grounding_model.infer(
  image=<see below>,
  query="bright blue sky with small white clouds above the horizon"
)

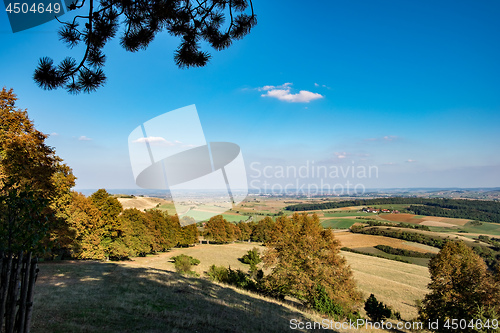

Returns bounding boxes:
[0,0,500,190]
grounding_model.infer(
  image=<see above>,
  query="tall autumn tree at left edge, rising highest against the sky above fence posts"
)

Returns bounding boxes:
[0,88,75,251]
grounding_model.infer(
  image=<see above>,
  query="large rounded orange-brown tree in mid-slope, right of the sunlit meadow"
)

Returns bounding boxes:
[263,214,361,317]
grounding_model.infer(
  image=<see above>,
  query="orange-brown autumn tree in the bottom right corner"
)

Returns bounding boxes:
[419,241,500,332]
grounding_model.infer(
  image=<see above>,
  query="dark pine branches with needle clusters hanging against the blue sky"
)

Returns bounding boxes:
[33,0,257,94]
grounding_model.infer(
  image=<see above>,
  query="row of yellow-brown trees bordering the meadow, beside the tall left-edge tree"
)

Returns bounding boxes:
[49,189,198,260]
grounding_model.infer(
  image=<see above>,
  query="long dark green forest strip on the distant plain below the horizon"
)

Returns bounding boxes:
[285,197,500,223]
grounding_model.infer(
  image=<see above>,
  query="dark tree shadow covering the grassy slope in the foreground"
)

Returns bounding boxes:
[32,261,336,333]
